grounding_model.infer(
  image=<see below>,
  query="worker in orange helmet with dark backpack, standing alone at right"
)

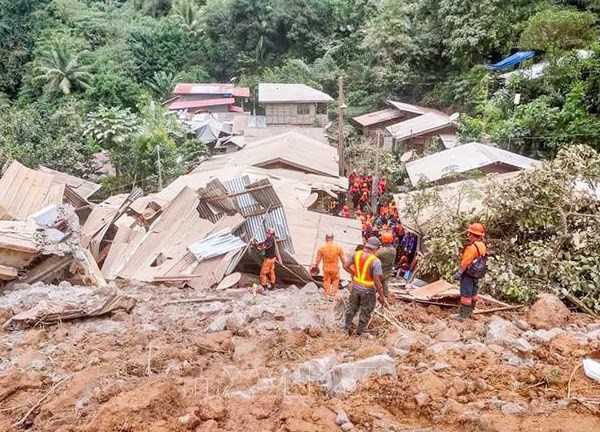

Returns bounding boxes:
[454,223,487,321]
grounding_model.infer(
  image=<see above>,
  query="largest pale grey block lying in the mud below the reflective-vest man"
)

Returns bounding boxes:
[327,355,397,395]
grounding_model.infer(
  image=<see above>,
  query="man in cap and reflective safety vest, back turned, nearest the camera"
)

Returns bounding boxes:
[344,237,387,336]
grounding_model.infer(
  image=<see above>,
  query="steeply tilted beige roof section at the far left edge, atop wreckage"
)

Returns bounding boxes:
[0,161,64,220]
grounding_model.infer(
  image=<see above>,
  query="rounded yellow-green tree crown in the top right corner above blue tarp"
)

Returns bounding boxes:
[520,9,597,52]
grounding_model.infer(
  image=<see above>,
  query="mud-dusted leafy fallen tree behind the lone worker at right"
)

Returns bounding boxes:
[403,145,600,313]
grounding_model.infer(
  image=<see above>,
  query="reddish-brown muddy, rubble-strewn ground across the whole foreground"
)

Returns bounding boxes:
[0,283,600,432]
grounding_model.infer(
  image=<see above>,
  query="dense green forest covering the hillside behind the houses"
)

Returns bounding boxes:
[0,0,600,192]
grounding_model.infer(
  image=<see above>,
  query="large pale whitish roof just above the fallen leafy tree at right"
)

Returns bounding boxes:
[406,142,537,185]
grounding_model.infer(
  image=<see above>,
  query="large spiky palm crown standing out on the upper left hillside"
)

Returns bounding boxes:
[35,44,91,95]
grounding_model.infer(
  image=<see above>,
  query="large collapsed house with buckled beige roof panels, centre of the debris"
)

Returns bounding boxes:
[81,132,361,289]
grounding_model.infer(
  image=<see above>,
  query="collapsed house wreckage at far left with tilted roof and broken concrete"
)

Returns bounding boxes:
[0,161,105,286]
